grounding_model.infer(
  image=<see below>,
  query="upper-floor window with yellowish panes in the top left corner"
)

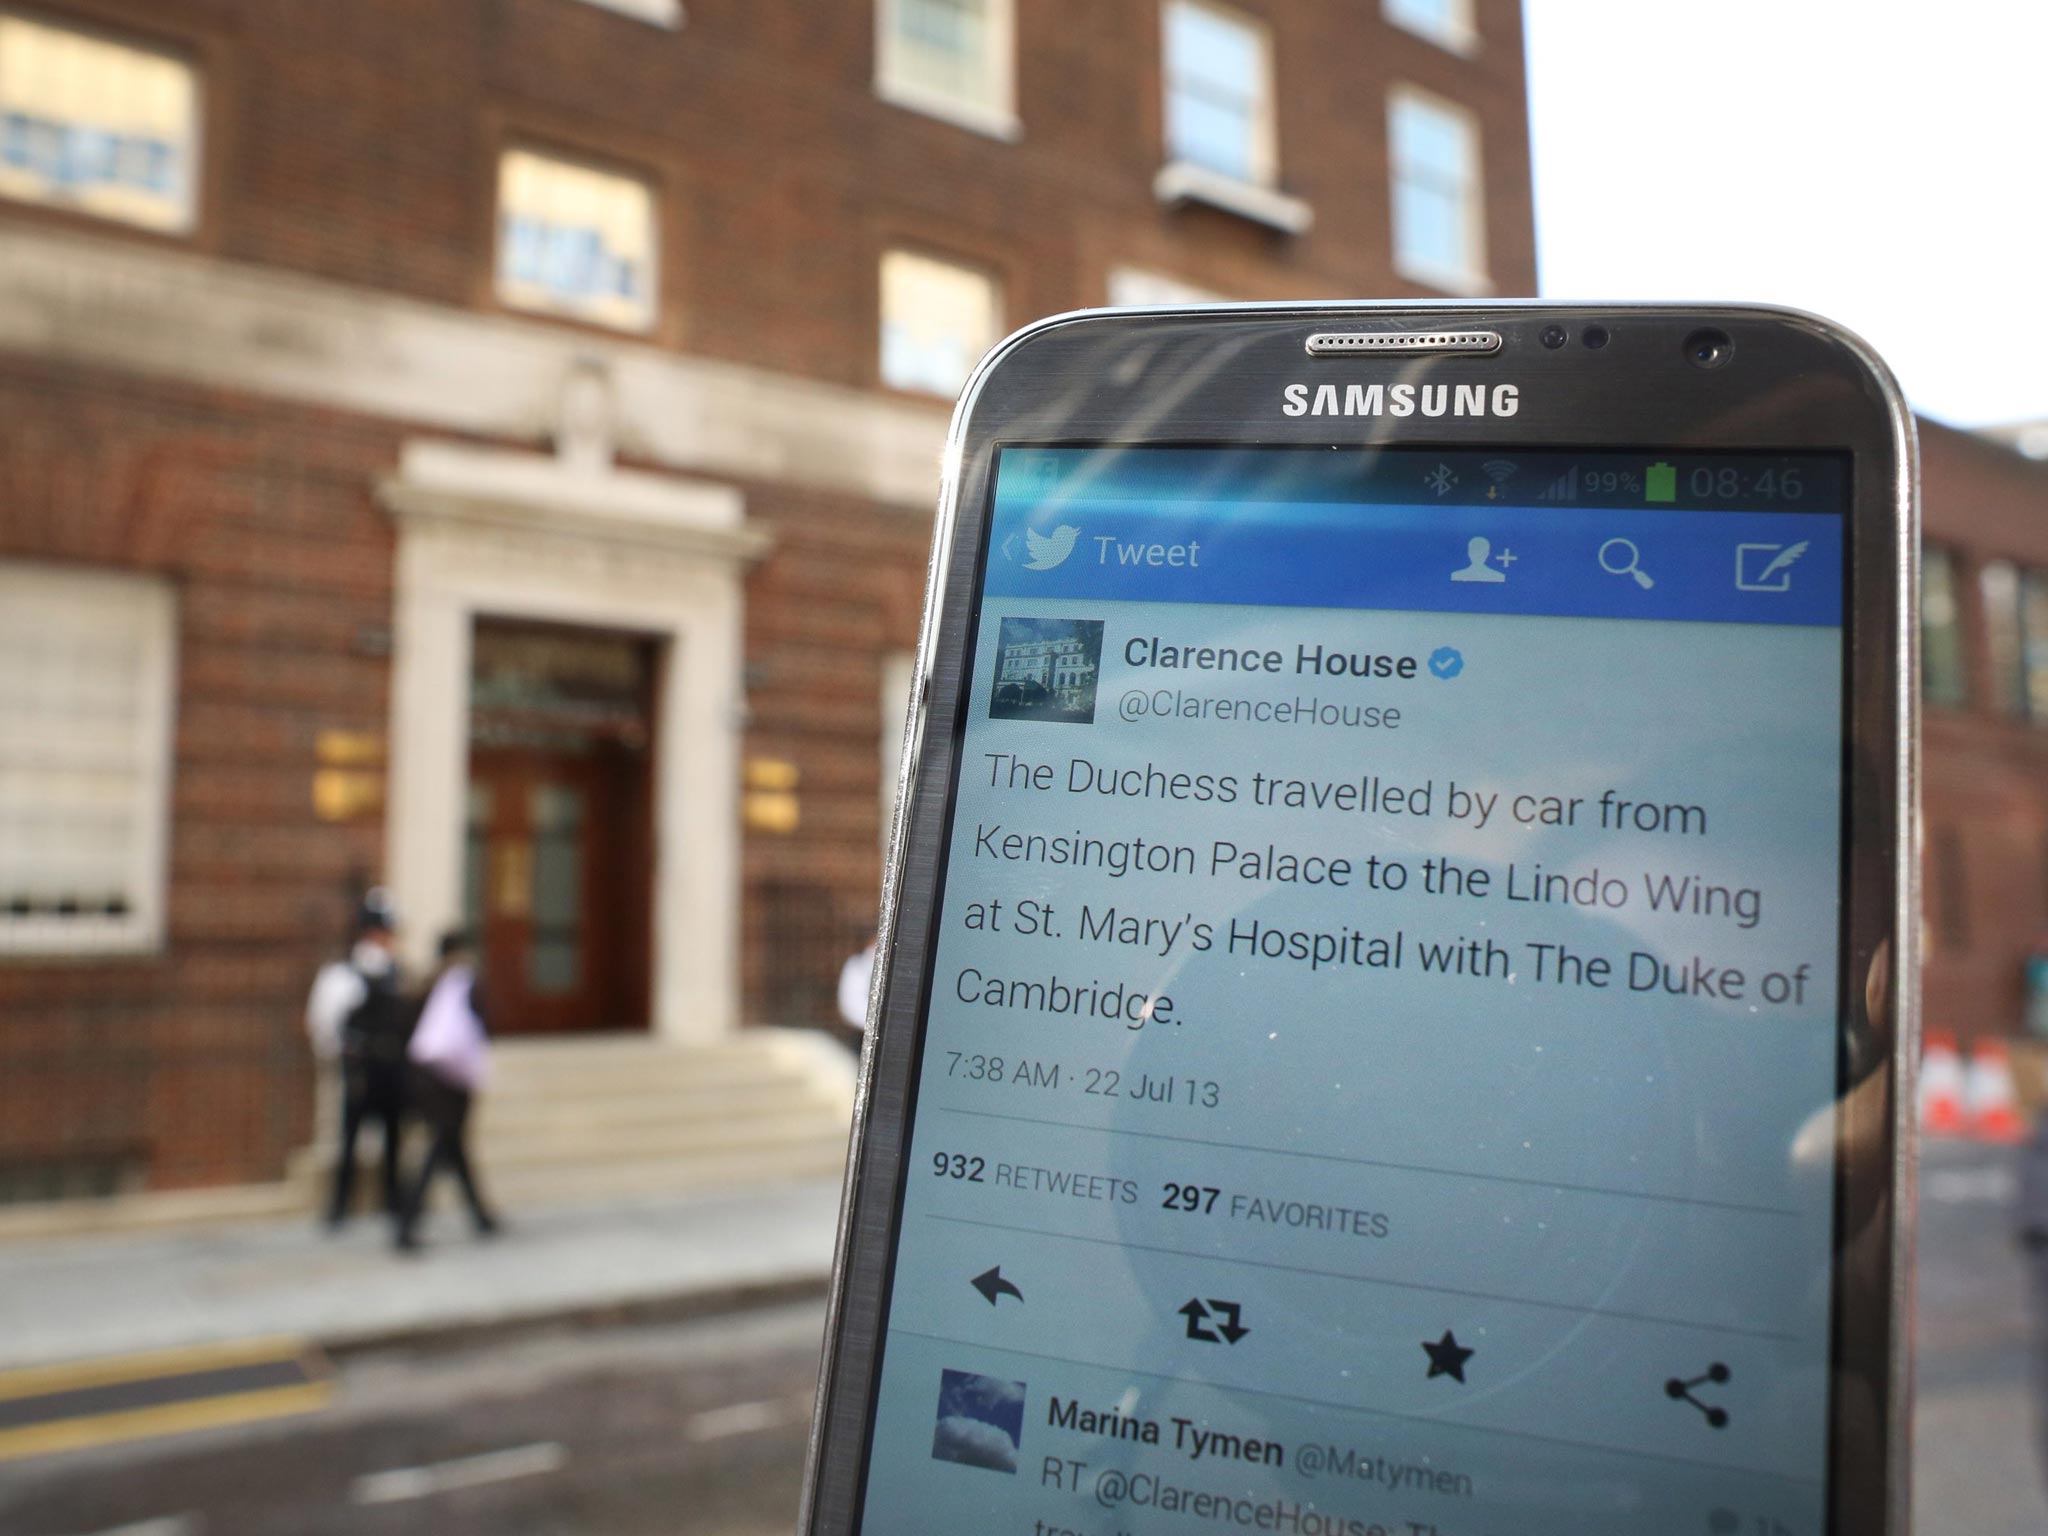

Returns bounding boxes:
[0,14,199,233]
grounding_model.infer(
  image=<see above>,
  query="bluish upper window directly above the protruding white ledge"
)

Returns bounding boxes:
[1165,0,1278,186]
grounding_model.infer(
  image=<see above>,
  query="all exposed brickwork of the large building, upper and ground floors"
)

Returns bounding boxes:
[0,0,1534,1186]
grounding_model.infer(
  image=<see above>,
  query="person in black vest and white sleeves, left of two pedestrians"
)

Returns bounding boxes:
[305,889,418,1229]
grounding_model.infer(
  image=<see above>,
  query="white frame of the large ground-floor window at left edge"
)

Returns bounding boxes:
[0,559,178,961]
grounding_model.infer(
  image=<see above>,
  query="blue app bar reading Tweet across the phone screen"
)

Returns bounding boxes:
[985,449,1843,627]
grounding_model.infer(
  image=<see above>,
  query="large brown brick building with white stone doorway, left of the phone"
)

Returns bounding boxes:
[0,0,1534,1200]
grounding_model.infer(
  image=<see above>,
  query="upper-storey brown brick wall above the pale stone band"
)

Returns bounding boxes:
[47,0,1536,372]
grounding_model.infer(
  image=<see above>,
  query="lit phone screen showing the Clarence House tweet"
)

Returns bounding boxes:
[862,446,1849,1536]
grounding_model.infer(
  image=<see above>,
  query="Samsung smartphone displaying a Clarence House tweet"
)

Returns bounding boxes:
[803,305,1915,1536]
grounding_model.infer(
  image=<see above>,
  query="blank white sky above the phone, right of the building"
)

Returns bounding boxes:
[1524,0,2048,426]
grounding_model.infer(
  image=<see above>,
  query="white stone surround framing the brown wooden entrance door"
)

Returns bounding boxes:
[381,421,770,1044]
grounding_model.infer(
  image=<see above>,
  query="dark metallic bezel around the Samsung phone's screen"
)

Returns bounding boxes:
[799,301,1919,1536]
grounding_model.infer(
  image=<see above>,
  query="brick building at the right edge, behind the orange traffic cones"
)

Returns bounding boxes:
[1921,422,2048,1040]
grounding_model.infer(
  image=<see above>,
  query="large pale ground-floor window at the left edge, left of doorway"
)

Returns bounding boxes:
[0,561,176,954]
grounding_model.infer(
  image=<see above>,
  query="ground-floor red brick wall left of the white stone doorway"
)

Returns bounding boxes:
[0,358,395,1186]
